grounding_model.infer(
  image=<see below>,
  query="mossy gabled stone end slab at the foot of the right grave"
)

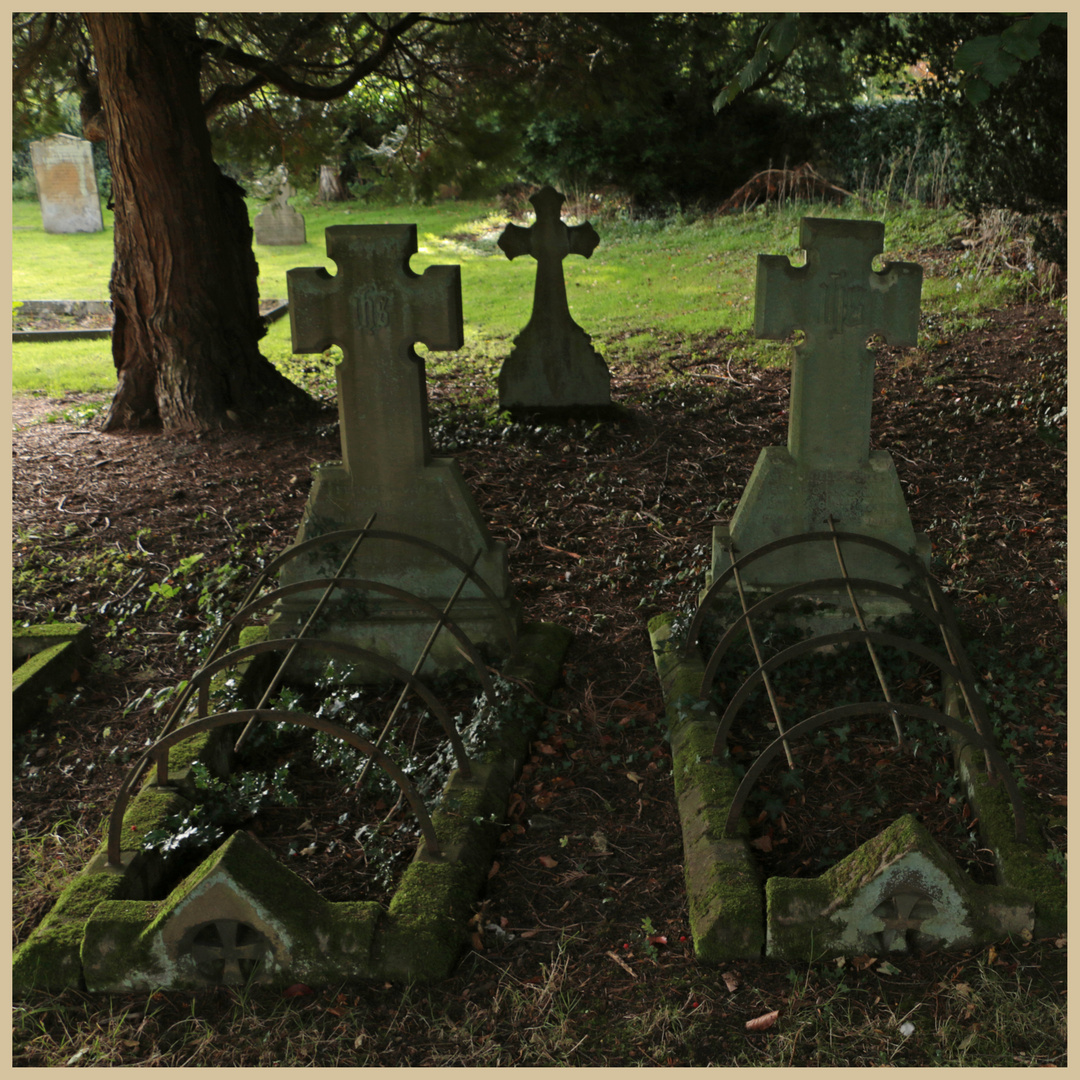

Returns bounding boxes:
[765,814,1035,961]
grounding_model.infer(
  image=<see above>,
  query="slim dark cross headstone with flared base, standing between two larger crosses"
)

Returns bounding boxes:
[499,186,611,411]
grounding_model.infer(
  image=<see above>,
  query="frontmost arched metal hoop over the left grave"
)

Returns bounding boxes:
[107,708,442,866]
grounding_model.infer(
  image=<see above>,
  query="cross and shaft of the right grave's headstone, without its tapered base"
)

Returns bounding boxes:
[754,217,922,471]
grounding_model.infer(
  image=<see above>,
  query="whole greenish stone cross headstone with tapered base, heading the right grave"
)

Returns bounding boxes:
[713,218,922,590]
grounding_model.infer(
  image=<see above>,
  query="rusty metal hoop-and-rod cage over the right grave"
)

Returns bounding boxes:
[684,516,1027,840]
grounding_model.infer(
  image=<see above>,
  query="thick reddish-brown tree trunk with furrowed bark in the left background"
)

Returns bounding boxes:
[85,13,313,431]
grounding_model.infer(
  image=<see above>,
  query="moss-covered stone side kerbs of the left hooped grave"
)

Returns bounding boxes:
[13,623,573,994]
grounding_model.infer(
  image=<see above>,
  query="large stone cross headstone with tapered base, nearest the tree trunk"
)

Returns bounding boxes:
[282,225,516,669]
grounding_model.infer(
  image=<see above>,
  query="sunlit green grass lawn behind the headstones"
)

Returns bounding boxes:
[12,197,1036,396]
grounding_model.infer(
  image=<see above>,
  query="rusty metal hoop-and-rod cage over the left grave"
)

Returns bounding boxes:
[107,514,516,866]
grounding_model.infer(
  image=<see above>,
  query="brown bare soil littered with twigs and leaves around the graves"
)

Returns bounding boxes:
[13,291,1066,1066]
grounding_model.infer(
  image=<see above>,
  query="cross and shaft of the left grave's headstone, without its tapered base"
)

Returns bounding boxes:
[286,225,464,490]
